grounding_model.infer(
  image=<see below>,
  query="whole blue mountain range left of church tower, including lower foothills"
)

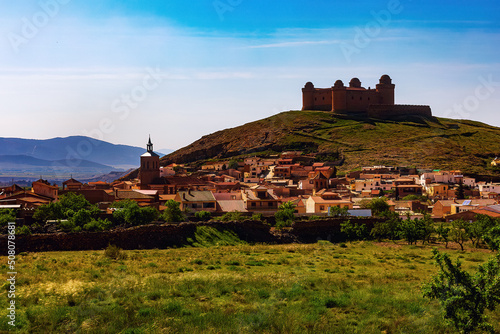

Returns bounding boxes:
[0,136,171,180]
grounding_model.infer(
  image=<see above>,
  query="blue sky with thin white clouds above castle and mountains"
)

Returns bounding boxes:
[0,0,500,149]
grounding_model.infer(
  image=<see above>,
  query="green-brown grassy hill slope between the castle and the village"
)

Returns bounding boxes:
[161,111,500,177]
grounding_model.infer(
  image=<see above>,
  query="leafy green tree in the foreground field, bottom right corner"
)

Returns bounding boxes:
[424,249,500,333]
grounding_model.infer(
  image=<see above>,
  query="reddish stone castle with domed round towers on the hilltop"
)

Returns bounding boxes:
[302,74,432,119]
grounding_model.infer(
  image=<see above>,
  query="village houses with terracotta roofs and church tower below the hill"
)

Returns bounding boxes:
[0,141,500,219]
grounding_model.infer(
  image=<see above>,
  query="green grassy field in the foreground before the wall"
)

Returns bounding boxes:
[0,228,500,333]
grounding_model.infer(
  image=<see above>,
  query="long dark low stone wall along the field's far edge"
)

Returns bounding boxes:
[0,218,386,253]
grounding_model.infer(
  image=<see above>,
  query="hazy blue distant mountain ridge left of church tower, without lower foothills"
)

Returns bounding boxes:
[0,136,145,168]
